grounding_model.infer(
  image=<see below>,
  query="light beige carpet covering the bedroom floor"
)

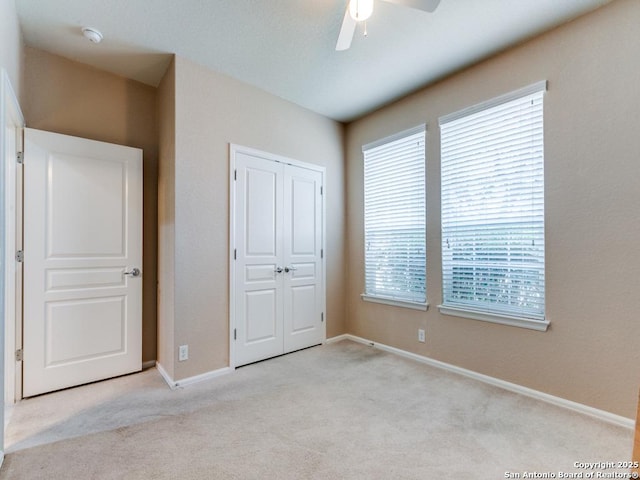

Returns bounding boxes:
[0,341,632,480]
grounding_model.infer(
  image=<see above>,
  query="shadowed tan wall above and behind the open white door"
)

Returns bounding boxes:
[22,47,158,361]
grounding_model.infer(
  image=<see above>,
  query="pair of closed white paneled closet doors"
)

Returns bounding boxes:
[232,151,325,366]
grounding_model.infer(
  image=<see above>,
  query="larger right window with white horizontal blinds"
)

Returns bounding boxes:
[440,82,548,330]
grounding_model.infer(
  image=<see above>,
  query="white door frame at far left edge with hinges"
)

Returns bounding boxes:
[0,68,25,464]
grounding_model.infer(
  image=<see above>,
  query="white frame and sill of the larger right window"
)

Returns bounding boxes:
[438,81,550,331]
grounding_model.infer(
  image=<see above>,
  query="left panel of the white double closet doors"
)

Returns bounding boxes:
[232,153,284,365]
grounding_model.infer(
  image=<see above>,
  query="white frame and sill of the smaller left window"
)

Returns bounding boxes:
[360,124,428,311]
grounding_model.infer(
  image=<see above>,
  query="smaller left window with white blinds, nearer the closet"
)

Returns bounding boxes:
[362,125,426,309]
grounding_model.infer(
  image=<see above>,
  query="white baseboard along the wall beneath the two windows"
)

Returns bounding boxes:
[340,334,635,430]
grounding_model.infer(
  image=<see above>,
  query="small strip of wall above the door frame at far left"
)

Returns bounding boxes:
[0,0,23,99]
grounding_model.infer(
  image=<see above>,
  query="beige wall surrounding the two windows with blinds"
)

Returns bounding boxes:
[346,0,640,418]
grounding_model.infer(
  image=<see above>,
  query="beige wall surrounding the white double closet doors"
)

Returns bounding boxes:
[160,57,345,380]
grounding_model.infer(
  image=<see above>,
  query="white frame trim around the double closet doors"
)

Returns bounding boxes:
[229,143,327,369]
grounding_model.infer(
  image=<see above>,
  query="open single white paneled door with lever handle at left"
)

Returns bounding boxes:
[23,129,142,397]
